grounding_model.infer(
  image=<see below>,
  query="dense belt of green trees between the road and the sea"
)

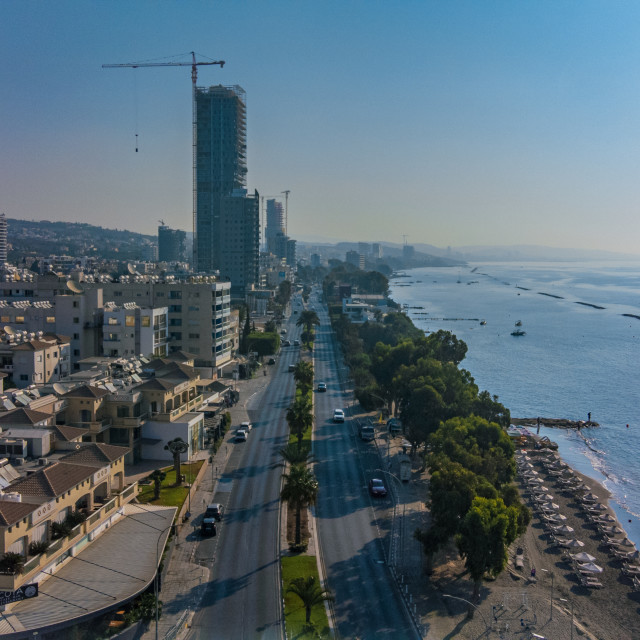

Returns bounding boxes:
[324,279,531,613]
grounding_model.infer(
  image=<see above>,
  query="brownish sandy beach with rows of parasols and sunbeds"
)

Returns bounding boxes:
[424,452,640,640]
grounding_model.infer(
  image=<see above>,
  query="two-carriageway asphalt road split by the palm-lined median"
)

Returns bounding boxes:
[188,297,418,640]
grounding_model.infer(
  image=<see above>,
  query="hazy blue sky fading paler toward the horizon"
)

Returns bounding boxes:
[0,0,640,253]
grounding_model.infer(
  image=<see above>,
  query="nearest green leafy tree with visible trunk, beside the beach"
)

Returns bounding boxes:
[456,498,517,618]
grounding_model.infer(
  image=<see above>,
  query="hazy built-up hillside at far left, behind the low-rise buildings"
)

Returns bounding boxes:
[7,218,157,262]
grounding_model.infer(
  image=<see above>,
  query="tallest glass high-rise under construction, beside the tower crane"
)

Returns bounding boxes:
[194,85,260,295]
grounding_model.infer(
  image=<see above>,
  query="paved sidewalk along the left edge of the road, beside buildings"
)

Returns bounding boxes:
[138,369,271,640]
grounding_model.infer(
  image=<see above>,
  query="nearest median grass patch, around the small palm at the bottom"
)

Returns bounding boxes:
[282,556,330,640]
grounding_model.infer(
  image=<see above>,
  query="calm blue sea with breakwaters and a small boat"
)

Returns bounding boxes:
[390,261,640,545]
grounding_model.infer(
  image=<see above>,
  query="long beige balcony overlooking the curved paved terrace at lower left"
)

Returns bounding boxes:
[0,482,138,591]
